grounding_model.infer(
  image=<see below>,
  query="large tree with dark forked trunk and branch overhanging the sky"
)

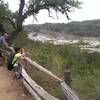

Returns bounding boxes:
[0,0,81,36]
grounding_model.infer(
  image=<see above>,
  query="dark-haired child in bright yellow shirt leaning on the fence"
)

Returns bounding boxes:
[12,47,25,79]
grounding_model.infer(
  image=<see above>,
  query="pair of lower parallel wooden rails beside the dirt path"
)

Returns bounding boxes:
[22,69,59,100]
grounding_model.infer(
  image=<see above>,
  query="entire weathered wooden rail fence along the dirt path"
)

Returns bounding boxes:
[4,50,80,100]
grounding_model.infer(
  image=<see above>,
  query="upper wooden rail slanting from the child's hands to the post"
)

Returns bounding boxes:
[25,57,63,82]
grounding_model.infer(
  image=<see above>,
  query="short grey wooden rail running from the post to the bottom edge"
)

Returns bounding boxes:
[60,82,80,100]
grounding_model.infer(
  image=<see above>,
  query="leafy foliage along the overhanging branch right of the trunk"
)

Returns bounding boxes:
[28,0,81,19]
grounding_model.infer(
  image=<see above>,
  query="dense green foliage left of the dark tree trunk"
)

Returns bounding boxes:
[0,0,15,33]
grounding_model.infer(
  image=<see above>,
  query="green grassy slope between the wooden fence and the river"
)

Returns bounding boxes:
[14,33,100,100]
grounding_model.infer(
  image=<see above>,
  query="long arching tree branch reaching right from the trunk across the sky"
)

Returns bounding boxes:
[23,2,74,19]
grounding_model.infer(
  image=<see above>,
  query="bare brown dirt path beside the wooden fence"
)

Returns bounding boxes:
[0,66,33,100]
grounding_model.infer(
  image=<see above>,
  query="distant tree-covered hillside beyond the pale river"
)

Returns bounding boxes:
[25,20,100,36]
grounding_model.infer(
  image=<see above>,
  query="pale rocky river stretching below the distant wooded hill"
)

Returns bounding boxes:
[28,33,100,52]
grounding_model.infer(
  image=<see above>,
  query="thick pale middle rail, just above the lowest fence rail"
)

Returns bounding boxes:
[22,69,59,100]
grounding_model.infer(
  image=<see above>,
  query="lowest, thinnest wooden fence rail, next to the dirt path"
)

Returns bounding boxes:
[22,80,41,100]
